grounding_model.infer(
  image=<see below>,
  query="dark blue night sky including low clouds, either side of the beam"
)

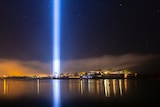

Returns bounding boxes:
[0,0,160,73]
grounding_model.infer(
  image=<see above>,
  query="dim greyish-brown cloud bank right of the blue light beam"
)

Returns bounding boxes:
[62,53,159,72]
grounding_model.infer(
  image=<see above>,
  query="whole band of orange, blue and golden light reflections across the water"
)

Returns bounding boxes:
[0,79,128,99]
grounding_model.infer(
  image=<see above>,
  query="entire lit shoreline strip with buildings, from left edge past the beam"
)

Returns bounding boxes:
[0,69,137,79]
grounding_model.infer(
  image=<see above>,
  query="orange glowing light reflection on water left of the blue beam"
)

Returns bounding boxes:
[0,79,52,98]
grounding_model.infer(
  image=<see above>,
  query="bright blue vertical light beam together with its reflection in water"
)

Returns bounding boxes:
[53,0,61,107]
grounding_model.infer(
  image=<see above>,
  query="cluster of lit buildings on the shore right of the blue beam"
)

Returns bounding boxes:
[55,69,137,79]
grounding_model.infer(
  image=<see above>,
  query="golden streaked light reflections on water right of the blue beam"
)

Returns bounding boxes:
[61,79,127,97]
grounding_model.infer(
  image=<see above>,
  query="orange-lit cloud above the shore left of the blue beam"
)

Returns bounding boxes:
[0,59,51,76]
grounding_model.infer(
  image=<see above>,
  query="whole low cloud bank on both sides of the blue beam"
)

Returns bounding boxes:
[0,53,160,76]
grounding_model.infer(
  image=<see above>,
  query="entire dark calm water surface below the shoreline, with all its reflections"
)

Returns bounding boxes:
[0,79,160,107]
